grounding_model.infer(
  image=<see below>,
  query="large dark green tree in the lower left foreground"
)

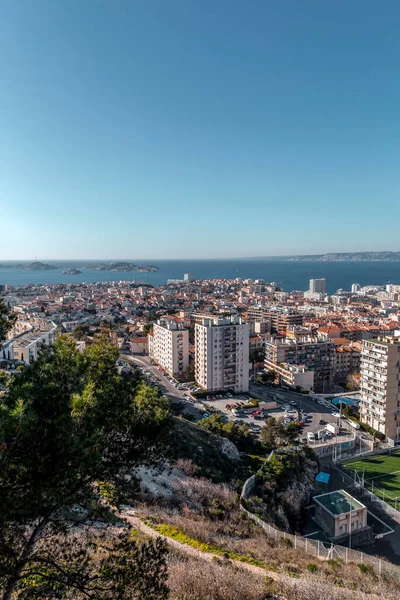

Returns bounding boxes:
[0,337,169,600]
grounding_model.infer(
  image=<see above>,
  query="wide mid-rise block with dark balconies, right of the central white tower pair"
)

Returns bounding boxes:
[265,336,335,392]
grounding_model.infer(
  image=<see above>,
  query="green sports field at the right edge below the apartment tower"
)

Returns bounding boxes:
[342,450,400,509]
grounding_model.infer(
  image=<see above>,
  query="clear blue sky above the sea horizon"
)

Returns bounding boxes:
[0,0,400,259]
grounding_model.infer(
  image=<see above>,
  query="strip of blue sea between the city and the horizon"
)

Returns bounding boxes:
[0,259,400,294]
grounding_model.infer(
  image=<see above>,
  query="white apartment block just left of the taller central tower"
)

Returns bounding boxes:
[148,317,189,375]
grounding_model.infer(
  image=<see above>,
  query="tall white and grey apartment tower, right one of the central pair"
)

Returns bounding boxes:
[195,315,249,393]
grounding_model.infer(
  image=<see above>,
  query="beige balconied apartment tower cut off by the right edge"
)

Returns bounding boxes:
[360,336,400,444]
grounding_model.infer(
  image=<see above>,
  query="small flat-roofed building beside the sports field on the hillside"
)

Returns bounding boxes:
[314,490,373,543]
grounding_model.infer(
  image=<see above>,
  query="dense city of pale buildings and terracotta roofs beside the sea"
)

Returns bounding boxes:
[0,274,400,444]
